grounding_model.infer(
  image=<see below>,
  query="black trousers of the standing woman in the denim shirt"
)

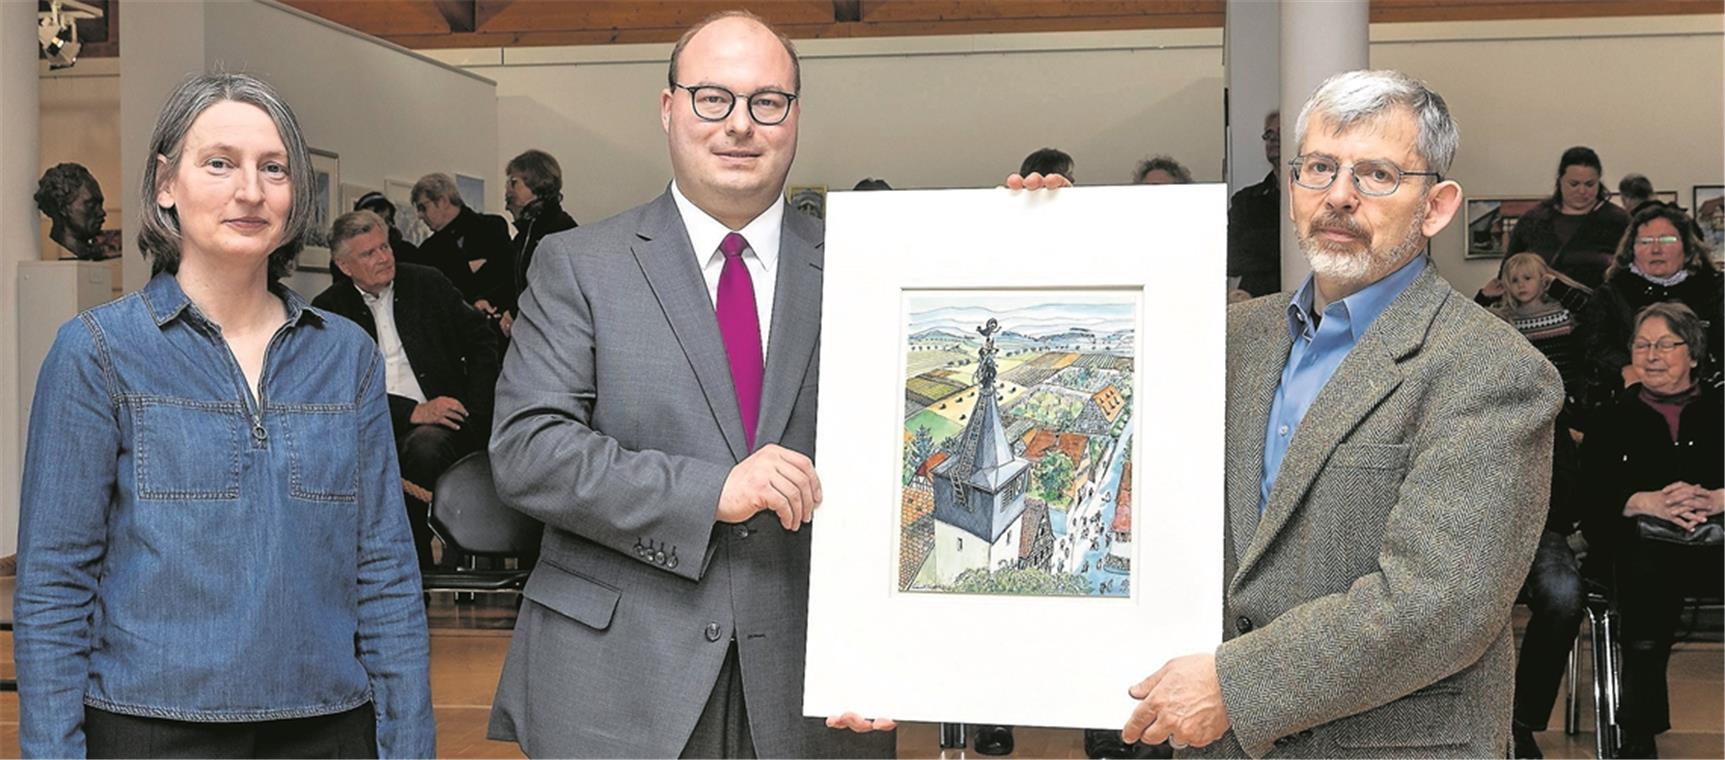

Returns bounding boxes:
[85,701,378,758]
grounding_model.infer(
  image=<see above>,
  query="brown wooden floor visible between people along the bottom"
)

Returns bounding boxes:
[0,595,1725,758]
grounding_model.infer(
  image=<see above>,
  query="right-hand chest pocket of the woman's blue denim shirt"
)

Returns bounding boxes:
[274,403,359,503]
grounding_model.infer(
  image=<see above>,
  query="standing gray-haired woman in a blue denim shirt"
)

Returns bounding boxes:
[14,74,435,757]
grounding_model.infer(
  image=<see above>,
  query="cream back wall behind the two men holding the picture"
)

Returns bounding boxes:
[451,14,1725,291]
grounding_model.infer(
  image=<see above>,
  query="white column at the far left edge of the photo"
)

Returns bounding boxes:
[0,2,41,555]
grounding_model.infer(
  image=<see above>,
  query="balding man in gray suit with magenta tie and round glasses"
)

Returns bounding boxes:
[490,14,894,757]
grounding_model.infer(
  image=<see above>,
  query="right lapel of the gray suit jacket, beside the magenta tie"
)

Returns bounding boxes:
[756,209,825,446]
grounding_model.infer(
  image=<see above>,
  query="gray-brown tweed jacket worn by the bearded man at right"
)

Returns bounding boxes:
[1194,269,1563,757]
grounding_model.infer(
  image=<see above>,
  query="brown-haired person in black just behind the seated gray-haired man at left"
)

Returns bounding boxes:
[412,174,516,308]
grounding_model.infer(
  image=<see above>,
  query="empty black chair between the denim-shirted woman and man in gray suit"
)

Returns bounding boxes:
[423,452,545,593]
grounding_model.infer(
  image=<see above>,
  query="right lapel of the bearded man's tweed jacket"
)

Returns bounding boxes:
[1230,264,1449,579]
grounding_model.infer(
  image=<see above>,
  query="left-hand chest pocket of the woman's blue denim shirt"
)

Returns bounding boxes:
[124,396,247,501]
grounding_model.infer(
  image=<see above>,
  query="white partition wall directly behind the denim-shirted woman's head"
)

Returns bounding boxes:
[121,2,502,295]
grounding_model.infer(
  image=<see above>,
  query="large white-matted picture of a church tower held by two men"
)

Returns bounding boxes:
[804,184,1226,727]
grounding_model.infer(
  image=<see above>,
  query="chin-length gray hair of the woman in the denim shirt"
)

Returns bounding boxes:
[138,74,312,281]
